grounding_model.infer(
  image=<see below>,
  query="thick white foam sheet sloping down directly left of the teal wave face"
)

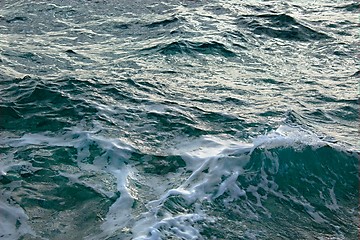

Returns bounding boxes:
[128,136,255,240]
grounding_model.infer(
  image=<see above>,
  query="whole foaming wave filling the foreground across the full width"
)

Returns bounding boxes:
[0,125,359,239]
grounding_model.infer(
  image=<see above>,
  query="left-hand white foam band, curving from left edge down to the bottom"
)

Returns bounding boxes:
[0,128,134,239]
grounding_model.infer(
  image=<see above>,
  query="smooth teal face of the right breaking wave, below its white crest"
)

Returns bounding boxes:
[208,145,359,239]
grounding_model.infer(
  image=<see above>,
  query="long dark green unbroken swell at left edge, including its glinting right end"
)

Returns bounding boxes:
[0,76,174,132]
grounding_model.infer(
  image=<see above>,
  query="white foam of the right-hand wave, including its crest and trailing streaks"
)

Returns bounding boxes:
[128,126,326,240]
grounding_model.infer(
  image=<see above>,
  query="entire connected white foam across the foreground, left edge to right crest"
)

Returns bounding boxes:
[0,126,336,239]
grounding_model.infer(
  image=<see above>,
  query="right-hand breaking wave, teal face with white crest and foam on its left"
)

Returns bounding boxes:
[134,126,359,239]
